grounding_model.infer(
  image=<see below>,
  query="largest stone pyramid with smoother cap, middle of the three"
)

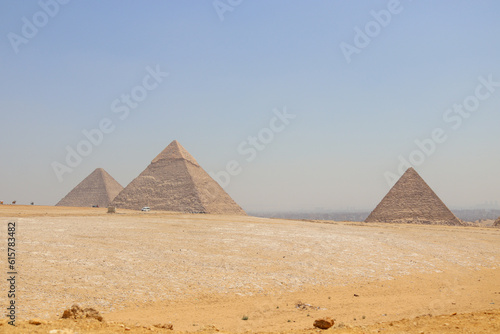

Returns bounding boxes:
[112,140,246,215]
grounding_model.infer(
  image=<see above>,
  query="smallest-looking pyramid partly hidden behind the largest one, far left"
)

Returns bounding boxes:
[56,168,123,207]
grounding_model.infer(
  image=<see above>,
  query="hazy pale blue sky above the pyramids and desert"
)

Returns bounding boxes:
[0,0,500,211]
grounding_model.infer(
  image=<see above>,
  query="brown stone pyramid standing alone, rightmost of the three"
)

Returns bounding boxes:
[365,168,463,225]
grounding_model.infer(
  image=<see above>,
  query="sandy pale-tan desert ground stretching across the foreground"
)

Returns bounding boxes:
[0,205,500,334]
